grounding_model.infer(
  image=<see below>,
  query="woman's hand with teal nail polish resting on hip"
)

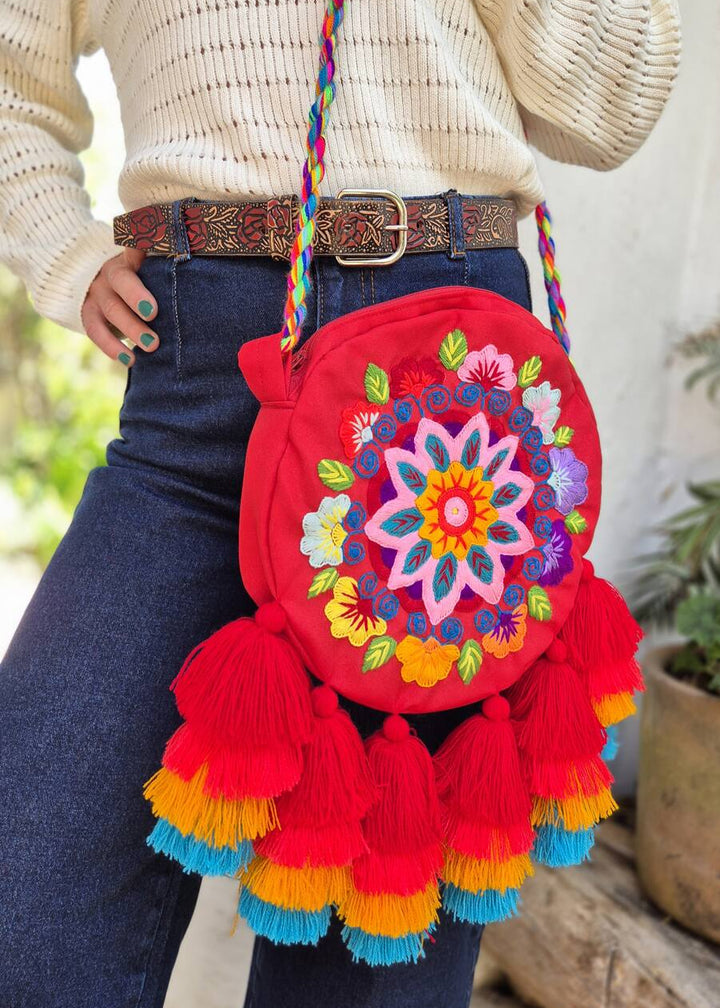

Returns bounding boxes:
[80,248,159,368]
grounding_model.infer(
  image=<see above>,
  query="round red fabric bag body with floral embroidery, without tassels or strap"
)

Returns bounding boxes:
[239,287,601,713]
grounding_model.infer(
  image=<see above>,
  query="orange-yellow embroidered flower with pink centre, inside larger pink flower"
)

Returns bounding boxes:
[415,462,498,560]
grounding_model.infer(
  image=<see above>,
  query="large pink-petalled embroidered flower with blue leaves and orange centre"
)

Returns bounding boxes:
[365,413,533,624]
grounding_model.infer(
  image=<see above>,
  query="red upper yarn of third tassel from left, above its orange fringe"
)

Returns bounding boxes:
[344,715,442,895]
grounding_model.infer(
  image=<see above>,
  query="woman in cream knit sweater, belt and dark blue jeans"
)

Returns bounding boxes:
[0,0,680,1008]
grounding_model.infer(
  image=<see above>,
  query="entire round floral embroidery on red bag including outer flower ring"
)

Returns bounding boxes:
[296,317,597,693]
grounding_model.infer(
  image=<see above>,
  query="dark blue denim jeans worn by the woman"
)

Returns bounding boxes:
[0,190,529,1008]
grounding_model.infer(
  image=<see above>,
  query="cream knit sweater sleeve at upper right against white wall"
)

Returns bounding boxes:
[475,0,681,170]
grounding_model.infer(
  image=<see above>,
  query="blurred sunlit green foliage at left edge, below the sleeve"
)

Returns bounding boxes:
[0,266,126,565]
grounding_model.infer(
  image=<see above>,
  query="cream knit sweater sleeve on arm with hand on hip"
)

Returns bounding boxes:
[0,0,120,333]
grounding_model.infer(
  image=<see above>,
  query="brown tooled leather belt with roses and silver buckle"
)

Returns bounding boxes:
[113,191,518,265]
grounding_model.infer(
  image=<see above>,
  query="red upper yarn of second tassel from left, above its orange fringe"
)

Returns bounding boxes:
[255,685,377,868]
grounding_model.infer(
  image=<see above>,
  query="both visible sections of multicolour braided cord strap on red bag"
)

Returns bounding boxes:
[280,0,570,354]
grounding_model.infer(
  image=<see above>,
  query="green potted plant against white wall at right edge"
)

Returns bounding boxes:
[630,323,720,696]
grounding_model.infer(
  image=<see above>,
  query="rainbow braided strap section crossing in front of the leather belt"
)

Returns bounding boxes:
[280,0,344,354]
